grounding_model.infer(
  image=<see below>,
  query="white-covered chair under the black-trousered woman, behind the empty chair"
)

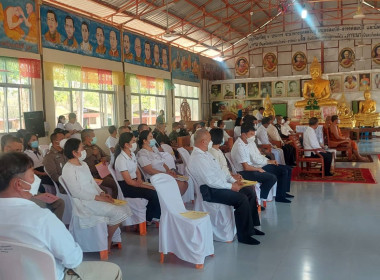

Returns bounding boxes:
[108,164,148,235]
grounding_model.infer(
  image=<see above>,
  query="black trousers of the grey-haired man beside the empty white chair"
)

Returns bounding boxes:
[200,185,260,240]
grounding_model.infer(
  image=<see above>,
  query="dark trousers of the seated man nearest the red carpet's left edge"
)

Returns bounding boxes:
[263,164,292,198]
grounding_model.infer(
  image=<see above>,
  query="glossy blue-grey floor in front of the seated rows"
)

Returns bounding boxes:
[85,140,380,280]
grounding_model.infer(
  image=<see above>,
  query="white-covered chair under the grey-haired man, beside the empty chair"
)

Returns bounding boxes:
[186,168,236,243]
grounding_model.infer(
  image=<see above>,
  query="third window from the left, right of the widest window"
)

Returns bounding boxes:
[130,76,166,125]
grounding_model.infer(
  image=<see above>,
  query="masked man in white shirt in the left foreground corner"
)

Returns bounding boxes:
[0,152,122,280]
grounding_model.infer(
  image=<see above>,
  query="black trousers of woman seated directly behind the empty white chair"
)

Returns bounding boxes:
[118,181,161,222]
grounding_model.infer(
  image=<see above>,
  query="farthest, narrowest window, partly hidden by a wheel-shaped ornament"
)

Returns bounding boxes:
[174,84,200,122]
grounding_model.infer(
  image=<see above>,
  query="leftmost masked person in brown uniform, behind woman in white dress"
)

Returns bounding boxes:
[43,133,67,193]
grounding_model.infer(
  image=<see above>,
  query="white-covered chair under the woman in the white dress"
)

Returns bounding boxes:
[59,176,121,260]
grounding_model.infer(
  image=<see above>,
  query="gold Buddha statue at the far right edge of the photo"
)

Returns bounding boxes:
[355,88,380,127]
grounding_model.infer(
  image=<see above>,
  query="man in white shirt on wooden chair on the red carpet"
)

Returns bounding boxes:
[303,117,333,176]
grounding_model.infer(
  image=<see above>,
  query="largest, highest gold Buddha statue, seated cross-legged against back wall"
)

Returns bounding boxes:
[295,57,338,107]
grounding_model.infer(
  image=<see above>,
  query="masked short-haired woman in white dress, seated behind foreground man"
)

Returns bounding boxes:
[62,138,132,250]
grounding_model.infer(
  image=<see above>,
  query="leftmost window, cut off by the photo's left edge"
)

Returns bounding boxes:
[0,57,32,133]
